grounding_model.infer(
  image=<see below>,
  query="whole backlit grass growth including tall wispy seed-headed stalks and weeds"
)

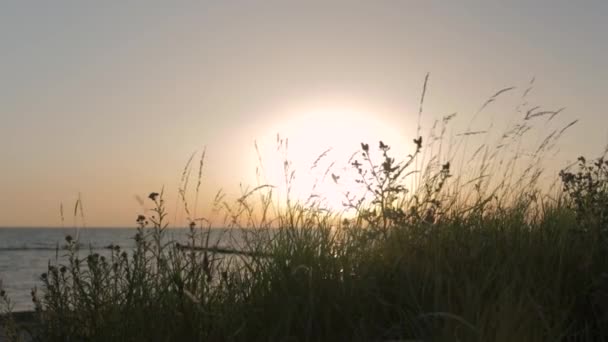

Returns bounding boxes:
[2,78,608,341]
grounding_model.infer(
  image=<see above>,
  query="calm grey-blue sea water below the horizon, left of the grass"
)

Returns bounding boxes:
[0,228,234,311]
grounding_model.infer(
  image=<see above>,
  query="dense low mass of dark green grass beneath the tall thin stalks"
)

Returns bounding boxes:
[28,186,608,341]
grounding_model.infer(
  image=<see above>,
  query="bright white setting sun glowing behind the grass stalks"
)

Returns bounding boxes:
[252,106,407,211]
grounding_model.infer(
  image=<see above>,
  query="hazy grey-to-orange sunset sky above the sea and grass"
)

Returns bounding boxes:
[0,0,608,226]
